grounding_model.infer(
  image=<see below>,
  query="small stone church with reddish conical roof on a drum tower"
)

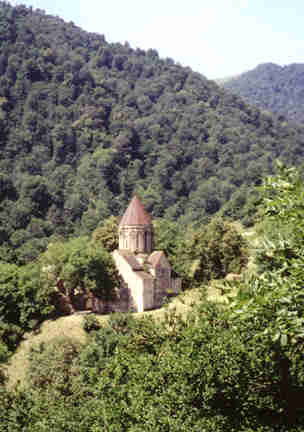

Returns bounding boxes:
[113,196,181,312]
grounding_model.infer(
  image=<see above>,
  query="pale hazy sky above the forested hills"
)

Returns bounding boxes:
[7,0,304,79]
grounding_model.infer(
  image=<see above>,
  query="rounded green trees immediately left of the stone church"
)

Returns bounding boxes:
[0,237,119,363]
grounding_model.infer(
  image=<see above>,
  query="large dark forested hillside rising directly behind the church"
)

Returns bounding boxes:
[0,2,304,264]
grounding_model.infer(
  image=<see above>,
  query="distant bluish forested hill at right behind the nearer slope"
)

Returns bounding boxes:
[219,63,304,123]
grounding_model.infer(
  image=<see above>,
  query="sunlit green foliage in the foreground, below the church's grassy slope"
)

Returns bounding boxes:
[0,167,304,432]
